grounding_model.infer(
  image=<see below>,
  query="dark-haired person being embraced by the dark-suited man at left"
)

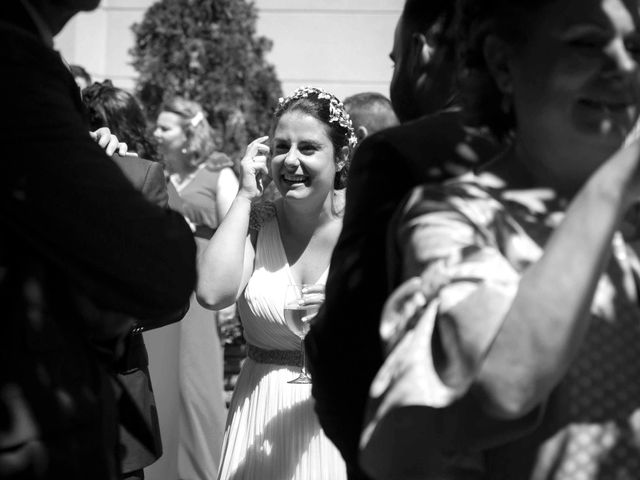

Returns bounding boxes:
[81,79,182,479]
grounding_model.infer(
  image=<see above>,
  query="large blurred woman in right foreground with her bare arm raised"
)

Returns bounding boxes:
[361,0,640,480]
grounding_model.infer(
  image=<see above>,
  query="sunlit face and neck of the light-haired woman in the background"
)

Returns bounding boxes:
[153,112,194,173]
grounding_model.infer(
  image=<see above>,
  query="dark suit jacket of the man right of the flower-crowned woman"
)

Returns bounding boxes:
[306,111,497,479]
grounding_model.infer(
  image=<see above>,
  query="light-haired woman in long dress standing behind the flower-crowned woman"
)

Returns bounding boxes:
[154,97,238,480]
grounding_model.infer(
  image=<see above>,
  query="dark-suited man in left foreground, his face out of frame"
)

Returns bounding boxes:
[0,0,195,480]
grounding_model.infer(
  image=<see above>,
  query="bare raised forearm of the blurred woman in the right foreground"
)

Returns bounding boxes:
[477,143,640,418]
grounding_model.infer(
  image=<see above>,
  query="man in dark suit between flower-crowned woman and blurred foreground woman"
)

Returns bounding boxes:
[305,0,496,480]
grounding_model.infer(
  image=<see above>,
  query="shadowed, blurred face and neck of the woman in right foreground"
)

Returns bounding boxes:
[508,0,640,195]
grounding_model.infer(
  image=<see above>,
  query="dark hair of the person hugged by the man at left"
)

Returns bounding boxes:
[82,80,158,161]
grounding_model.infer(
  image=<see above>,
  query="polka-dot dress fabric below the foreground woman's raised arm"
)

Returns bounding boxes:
[555,249,640,480]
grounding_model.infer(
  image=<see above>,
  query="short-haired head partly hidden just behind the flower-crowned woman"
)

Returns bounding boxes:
[343,92,398,142]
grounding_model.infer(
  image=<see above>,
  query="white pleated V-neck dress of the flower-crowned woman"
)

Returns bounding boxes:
[218,216,346,480]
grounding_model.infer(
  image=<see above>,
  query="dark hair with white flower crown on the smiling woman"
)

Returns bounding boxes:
[271,87,356,190]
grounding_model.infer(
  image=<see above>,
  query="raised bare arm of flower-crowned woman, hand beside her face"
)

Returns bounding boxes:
[196,137,269,310]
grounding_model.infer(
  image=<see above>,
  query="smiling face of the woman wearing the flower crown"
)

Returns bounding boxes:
[270,110,336,199]
